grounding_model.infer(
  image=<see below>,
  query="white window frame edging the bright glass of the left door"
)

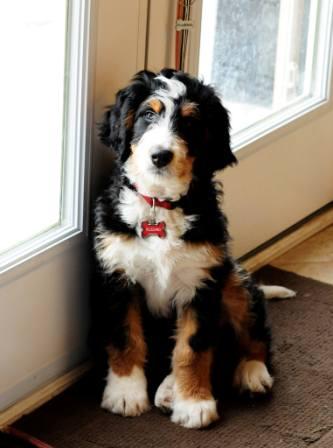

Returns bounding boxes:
[0,0,93,276]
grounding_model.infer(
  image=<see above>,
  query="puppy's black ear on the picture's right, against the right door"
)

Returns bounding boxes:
[205,92,237,171]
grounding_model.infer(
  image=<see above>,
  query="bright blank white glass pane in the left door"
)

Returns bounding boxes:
[0,0,67,253]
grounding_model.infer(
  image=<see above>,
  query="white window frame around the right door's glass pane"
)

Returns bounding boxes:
[187,0,333,155]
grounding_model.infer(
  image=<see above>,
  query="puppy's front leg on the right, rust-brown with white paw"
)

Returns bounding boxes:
[171,307,218,428]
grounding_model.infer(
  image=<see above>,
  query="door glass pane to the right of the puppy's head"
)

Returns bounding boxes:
[199,0,326,133]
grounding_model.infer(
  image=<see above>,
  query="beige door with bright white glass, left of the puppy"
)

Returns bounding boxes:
[0,0,93,410]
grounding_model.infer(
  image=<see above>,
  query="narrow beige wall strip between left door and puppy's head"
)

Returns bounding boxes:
[92,0,148,195]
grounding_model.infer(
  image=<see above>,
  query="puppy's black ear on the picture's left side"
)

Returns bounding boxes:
[99,70,156,161]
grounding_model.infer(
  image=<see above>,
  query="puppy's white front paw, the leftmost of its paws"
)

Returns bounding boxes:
[101,367,150,417]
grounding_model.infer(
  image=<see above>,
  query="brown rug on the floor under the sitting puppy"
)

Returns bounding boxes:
[10,267,333,448]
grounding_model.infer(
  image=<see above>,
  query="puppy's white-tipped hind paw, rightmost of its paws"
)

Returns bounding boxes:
[234,360,274,393]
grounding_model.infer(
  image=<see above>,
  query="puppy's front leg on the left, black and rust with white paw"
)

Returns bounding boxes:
[98,274,150,417]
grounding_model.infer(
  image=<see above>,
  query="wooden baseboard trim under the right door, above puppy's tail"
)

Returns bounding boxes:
[240,207,333,272]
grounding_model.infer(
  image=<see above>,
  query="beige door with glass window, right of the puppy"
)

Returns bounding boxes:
[146,0,333,256]
